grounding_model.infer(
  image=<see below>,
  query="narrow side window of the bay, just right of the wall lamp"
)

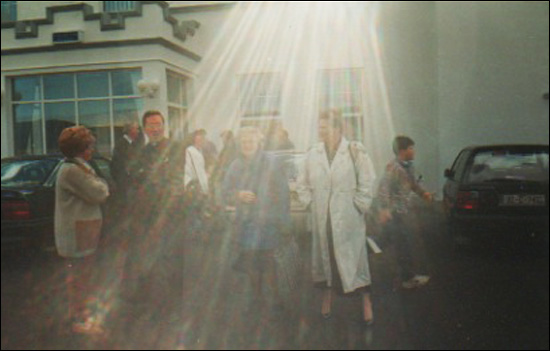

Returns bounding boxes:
[166,71,189,140]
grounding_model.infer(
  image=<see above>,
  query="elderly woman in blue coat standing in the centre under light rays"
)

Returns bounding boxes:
[223,127,290,310]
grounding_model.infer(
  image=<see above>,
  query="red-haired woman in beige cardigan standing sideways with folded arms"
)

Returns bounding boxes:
[55,127,109,334]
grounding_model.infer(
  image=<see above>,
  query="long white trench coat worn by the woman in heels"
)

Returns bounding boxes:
[297,139,375,293]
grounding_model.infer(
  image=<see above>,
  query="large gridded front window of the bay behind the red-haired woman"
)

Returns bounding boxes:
[12,69,143,155]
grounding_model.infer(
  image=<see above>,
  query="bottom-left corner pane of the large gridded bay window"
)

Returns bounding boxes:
[13,104,44,155]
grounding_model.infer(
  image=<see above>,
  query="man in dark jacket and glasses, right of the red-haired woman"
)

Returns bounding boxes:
[122,110,185,320]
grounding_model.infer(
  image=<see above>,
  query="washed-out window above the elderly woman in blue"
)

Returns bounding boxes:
[239,73,282,120]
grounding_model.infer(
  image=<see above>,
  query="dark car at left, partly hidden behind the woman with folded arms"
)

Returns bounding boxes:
[2,155,114,248]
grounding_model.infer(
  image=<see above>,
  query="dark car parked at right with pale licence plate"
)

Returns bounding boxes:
[443,145,548,245]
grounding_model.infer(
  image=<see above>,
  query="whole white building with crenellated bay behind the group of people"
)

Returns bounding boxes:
[1,1,549,189]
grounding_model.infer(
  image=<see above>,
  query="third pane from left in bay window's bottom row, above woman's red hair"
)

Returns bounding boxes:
[78,101,111,155]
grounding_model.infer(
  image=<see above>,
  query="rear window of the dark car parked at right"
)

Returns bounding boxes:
[468,150,548,183]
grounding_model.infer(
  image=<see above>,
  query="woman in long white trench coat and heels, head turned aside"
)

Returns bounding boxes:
[298,110,375,324]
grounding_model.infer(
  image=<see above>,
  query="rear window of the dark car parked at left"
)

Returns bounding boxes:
[2,160,58,188]
